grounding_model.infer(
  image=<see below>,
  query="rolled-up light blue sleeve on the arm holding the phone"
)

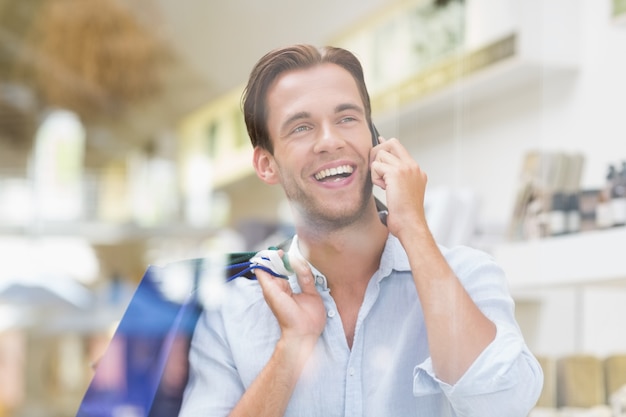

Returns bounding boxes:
[413,250,543,417]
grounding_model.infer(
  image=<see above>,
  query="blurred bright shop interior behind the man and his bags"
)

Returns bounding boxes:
[0,0,626,416]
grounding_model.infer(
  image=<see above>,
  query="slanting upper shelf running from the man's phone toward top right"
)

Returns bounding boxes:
[372,0,580,134]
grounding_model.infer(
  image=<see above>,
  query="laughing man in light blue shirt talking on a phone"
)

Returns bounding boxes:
[181,45,542,417]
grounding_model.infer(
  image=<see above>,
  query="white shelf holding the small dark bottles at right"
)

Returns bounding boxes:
[494,227,626,292]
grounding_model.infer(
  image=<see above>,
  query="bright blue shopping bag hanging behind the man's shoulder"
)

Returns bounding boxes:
[76,258,204,417]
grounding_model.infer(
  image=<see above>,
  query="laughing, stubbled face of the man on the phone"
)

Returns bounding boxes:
[255,64,372,227]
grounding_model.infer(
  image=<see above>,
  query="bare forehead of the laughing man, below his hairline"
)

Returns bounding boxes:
[267,63,363,118]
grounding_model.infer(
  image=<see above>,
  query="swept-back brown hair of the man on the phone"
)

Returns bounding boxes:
[242,45,372,153]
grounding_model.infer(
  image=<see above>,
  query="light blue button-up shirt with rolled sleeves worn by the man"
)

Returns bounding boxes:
[180,236,543,417]
